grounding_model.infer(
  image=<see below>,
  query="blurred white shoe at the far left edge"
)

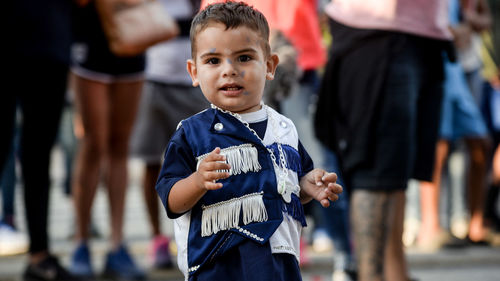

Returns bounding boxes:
[0,223,28,256]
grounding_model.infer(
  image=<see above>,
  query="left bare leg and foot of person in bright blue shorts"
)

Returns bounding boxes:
[418,140,449,246]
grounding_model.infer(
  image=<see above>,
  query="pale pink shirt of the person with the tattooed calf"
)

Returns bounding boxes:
[325,0,451,40]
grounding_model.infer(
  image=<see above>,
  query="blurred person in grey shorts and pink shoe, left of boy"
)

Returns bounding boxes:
[130,0,210,268]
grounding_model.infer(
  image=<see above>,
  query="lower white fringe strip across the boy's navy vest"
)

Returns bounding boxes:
[201,191,268,237]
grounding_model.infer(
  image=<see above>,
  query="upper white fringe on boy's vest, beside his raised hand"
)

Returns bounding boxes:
[196,143,262,175]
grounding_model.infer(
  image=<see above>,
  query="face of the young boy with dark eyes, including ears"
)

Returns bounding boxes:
[187,23,278,113]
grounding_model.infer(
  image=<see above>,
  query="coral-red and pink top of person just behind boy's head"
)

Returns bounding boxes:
[201,0,326,70]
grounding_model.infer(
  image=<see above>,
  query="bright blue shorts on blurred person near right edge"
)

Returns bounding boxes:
[439,61,488,140]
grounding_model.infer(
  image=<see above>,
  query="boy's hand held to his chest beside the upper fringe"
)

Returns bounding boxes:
[195,147,231,190]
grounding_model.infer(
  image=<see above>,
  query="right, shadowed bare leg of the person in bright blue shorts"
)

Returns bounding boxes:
[466,138,489,242]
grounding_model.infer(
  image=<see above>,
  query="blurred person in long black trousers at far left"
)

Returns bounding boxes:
[0,0,76,280]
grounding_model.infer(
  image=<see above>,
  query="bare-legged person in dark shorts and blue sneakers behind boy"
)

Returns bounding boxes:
[71,0,145,280]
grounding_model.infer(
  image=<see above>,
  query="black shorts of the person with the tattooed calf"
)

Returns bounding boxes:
[350,40,443,190]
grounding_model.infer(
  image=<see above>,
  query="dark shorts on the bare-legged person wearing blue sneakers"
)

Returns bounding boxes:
[71,2,146,83]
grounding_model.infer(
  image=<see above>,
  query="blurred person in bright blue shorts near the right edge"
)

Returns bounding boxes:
[417,0,491,249]
